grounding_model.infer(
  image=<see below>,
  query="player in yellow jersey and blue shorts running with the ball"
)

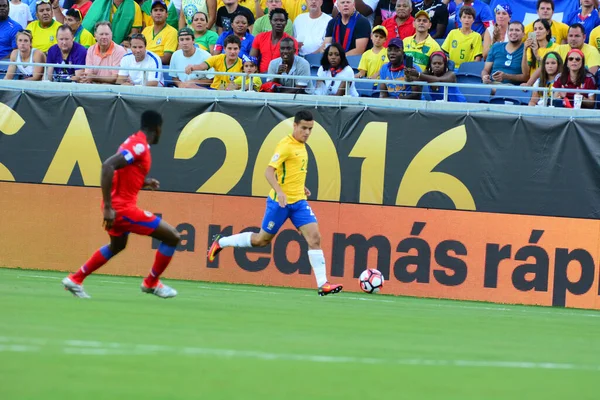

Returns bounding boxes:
[208,111,342,296]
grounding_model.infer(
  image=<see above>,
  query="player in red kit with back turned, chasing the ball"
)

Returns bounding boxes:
[62,111,180,298]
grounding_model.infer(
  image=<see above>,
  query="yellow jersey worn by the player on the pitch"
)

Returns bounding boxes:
[269,135,308,204]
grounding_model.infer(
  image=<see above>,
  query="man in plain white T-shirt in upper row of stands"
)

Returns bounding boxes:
[294,0,331,56]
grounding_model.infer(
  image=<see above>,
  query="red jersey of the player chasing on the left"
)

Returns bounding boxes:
[111,131,152,210]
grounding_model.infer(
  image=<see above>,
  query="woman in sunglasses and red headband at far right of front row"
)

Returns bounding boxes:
[552,49,597,108]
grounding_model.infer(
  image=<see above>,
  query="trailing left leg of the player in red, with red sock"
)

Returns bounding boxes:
[62,234,128,298]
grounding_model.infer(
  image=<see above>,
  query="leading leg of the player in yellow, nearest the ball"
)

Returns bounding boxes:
[290,200,343,296]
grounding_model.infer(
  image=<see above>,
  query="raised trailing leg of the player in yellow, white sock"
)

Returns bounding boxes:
[208,198,289,262]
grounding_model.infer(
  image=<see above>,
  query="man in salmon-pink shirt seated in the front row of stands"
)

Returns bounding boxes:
[79,21,131,84]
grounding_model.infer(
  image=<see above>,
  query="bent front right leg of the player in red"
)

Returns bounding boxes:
[141,217,181,298]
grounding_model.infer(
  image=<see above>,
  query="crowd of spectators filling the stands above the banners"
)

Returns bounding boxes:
[0,0,600,108]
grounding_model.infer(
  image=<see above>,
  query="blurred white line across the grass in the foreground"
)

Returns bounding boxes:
[0,336,600,371]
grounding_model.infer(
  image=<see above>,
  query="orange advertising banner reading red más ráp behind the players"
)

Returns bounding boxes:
[0,182,600,309]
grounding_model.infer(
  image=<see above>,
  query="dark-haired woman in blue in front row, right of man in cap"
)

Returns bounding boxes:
[406,51,467,103]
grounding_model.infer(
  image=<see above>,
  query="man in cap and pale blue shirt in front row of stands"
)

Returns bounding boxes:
[169,27,212,89]
